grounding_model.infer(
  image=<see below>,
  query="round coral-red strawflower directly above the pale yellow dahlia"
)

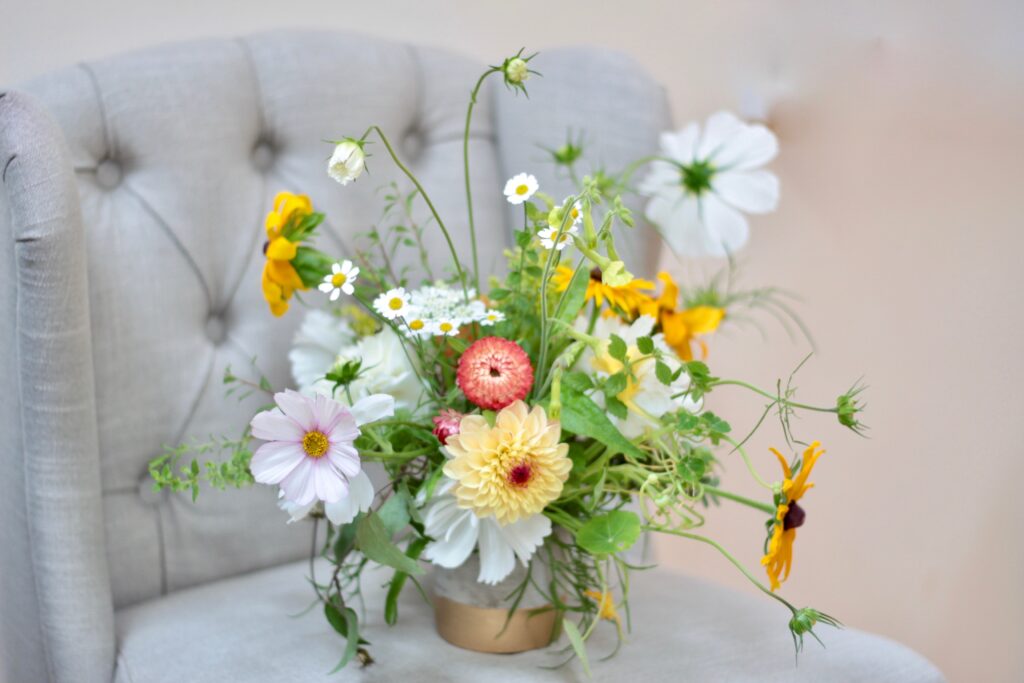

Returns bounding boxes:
[456,337,534,411]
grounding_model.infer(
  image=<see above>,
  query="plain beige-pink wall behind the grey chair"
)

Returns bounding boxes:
[0,0,1024,681]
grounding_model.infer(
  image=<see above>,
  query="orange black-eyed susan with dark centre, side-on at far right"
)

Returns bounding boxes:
[761,441,824,591]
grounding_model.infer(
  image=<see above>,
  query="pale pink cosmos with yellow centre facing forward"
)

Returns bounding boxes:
[249,390,394,505]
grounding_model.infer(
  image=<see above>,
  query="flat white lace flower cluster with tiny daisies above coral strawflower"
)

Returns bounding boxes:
[374,283,505,338]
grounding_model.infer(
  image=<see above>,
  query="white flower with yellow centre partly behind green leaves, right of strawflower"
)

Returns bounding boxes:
[575,315,701,438]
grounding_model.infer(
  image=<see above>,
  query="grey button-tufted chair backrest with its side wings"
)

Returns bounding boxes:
[0,32,669,681]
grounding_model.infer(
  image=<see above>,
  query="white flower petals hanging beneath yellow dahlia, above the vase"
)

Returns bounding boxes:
[423,477,551,585]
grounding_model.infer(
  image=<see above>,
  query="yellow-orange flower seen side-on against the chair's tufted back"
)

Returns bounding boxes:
[260,193,313,316]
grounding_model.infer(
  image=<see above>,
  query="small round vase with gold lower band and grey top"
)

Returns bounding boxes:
[433,554,555,654]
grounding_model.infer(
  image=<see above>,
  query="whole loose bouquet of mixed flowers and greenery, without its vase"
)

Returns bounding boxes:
[151,51,862,668]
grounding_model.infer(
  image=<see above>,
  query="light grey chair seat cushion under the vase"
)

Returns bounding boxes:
[116,562,943,683]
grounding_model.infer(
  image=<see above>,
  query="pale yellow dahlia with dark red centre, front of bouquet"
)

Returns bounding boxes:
[444,400,572,526]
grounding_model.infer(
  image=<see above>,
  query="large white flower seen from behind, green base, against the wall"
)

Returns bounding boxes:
[639,112,778,256]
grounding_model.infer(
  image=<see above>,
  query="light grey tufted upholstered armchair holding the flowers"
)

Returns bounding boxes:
[0,32,941,683]
